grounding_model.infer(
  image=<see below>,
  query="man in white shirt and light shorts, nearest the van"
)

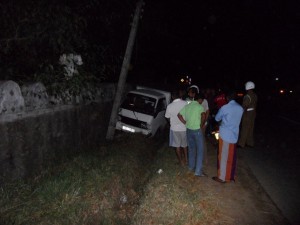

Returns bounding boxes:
[165,91,187,166]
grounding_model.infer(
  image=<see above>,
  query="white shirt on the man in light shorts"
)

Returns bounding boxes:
[165,98,187,131]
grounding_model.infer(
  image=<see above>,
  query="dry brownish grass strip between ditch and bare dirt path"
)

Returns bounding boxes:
[132,142,219,225]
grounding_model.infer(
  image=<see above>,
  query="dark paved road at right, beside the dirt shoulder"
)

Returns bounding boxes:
[238,111,300,225]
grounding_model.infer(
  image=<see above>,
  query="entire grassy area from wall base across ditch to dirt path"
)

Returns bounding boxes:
[0,134,218,225]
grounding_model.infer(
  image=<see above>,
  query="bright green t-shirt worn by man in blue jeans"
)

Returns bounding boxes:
[179,101,204,130]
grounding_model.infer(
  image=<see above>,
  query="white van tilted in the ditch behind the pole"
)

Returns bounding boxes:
[116,86,171,136]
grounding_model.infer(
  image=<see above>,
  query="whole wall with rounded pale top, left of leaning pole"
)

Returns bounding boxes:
[0,81,130,182]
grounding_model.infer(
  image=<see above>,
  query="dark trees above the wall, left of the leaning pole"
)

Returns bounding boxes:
[0,0,135,87]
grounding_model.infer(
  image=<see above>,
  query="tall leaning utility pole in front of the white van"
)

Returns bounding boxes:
[106,0,144,141]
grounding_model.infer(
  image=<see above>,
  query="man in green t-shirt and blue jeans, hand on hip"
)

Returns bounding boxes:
[178,94,206,177]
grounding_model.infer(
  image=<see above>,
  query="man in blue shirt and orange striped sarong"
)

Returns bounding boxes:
[212,91,244,183]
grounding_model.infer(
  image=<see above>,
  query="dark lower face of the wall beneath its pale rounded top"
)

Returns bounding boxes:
[0,103,111,178]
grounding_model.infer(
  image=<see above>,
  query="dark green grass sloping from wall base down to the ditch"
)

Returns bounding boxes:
[0,134,161,224]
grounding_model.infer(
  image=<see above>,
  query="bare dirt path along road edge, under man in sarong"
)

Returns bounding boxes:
[203,137,289,225]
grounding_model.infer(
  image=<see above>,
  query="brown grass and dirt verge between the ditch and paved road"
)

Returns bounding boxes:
[133,134,289,225]
